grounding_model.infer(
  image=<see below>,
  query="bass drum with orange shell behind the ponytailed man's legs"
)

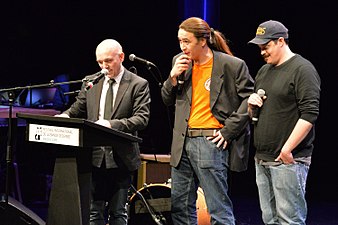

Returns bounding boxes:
[128,183,210,225]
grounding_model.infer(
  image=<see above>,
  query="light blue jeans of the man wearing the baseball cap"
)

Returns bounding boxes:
[255,162,309,225]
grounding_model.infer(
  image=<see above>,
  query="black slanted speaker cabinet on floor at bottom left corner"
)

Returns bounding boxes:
[0,197,46,225]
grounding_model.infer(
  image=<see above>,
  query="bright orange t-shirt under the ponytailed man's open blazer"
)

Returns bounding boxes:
[188,58,223,128]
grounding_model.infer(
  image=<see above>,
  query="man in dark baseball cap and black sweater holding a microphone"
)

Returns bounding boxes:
[248,20,321,225]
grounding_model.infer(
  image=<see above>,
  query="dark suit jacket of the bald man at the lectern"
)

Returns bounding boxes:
[64,69,151,171]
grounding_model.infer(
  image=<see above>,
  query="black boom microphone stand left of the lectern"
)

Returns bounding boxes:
[0,80,84,205]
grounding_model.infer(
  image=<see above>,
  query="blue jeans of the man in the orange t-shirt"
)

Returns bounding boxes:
[171,137,235,225]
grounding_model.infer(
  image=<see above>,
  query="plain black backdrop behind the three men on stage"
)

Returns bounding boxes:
[0,0,338,213]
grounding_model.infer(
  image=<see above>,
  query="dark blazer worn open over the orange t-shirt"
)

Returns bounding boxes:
[161,51,254,171]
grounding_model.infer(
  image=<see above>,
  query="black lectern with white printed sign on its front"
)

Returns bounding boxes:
[17,113,142,225]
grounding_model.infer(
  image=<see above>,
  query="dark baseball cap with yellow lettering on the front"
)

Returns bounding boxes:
[248,20,289,45]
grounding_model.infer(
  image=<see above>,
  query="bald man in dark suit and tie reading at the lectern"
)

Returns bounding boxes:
[59,39,151,225]
